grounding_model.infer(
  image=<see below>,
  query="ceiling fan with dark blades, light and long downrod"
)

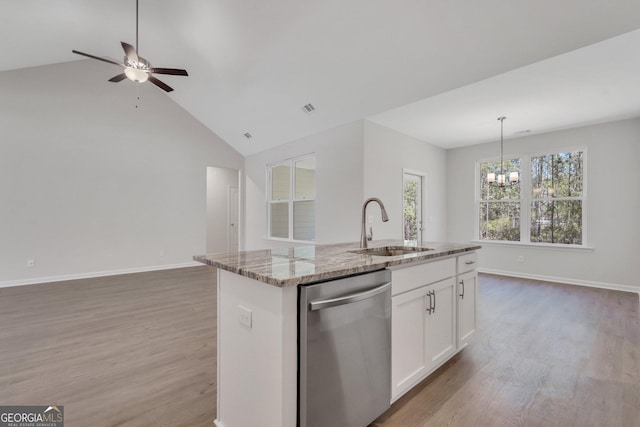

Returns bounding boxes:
[71,0,189,92]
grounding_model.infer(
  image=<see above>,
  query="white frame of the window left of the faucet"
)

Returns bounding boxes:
[265,153,317,244]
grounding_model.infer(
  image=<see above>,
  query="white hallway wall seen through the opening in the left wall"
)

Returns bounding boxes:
[206,167,239,254]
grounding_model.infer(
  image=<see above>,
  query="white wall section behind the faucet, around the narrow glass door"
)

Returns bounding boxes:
[364,121,448,241]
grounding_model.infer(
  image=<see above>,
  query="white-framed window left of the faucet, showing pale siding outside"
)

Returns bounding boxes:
[267,156,316,241]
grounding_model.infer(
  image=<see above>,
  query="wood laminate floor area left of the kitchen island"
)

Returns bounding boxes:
[0,266,216,427]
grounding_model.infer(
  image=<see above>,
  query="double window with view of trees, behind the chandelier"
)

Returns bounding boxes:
[477,150,586,245]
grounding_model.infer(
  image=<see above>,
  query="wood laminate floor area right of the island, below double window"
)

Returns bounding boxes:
[372,274,640,427]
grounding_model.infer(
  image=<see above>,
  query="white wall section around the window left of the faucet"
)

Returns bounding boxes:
[245,121,363,249]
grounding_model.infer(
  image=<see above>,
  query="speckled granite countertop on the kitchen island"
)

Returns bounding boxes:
[193,240,481,287]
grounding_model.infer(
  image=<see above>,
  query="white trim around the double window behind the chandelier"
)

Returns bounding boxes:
[473,146,594,247]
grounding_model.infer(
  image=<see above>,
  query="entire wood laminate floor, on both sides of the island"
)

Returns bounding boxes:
[0,267,640,427]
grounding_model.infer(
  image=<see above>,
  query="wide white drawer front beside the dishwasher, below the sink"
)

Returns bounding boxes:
[391,258,456,295]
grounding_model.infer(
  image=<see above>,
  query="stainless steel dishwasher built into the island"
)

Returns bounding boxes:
[298,270,391,427]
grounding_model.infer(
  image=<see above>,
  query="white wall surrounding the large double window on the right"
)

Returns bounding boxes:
[447,118,640,291]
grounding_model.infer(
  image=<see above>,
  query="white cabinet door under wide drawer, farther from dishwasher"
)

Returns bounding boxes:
[425,278,457,371]
